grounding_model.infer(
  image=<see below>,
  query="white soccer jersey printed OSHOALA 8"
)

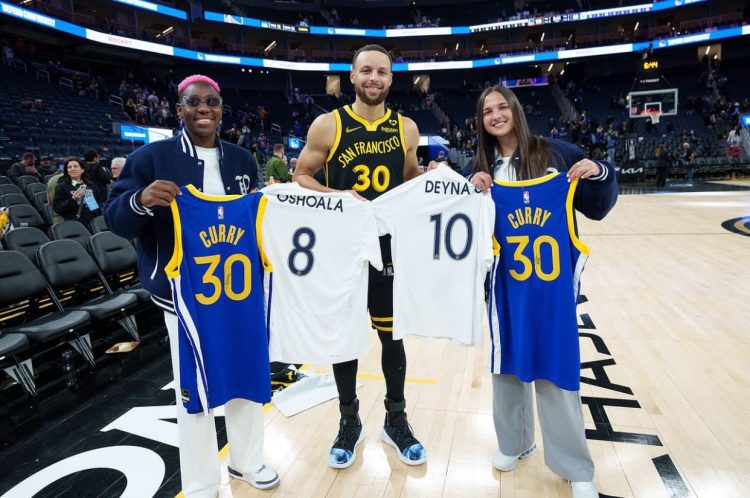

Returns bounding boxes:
[262,183,382,363]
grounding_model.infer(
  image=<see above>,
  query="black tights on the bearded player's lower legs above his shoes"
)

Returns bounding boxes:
[333,331,406,405]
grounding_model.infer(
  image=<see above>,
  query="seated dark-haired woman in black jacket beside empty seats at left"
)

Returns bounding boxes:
[52,157,104,225]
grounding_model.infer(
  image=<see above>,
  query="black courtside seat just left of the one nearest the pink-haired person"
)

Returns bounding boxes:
[37,240,139,340]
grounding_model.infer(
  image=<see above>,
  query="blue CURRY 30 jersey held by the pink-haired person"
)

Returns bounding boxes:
[166,185,271,413]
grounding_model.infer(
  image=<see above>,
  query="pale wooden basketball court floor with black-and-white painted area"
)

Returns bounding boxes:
[0,181,750,498]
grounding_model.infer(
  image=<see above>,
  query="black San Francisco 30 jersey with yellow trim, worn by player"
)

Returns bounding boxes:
[323,105,406,200]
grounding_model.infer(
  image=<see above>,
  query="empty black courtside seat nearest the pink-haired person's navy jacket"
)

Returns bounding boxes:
[88,231,151,303]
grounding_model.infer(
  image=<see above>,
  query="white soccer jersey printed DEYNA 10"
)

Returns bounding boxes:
[373,166,495,347]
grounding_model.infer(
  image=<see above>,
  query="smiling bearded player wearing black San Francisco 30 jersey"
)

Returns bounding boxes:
[294,45,427,468]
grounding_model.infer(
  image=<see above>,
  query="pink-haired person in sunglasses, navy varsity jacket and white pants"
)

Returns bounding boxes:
[104,75,279,498]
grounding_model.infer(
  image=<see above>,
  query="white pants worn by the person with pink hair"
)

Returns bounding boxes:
[164,312,263,498]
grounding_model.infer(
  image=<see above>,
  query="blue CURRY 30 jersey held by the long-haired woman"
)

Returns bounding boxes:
[488,173,589,391]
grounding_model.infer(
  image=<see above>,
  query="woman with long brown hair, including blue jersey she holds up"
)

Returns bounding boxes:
[471,86,617,498]
